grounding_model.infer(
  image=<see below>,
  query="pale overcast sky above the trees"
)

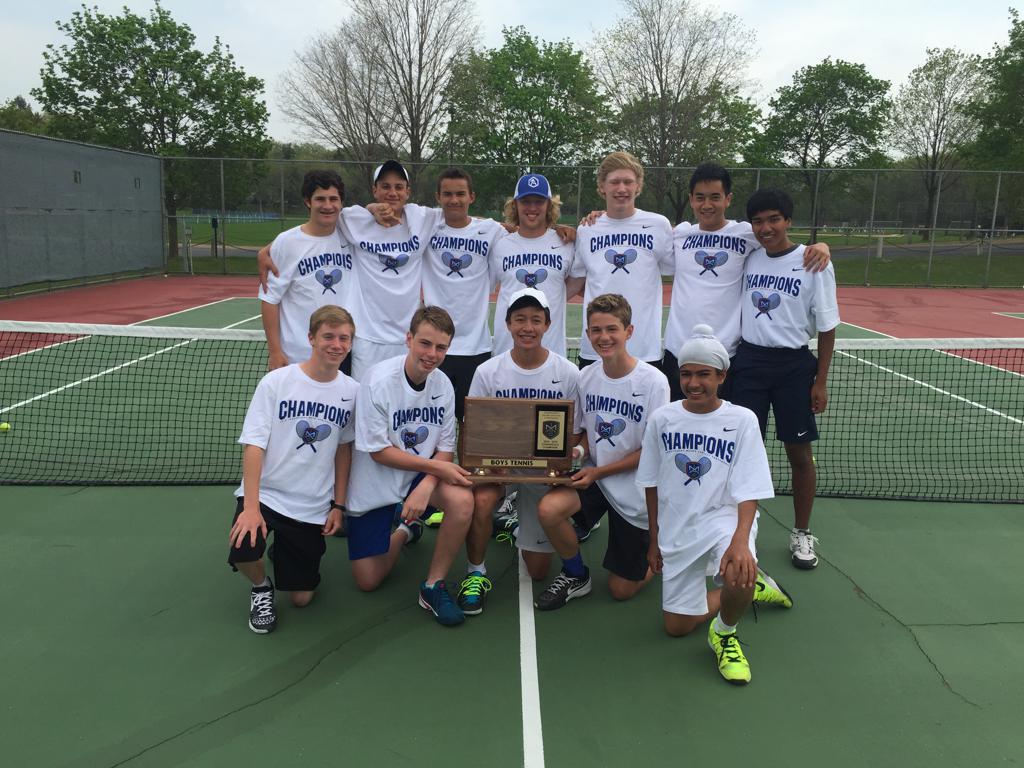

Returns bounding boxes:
[0,0,1024,140]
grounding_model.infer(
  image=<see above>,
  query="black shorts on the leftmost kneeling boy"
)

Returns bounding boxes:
[227,496,327,592]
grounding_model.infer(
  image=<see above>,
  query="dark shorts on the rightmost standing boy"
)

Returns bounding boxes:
[729,341,818,442]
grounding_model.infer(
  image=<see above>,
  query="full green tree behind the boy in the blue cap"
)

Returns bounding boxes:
[438,27,607,167]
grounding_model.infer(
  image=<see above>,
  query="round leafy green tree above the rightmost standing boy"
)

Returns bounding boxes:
[763,58,892,239]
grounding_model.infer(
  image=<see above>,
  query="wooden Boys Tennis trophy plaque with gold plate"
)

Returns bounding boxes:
[459,397,575,484]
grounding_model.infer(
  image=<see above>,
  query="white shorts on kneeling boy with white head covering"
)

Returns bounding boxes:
[662,516,758,616]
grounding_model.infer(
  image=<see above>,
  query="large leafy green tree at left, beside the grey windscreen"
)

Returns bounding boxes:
[32,3,269,260]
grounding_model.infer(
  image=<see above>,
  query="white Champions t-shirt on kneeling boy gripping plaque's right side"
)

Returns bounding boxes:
[577,360,669,530]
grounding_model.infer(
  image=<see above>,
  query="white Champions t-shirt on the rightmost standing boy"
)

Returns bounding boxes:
[740,246,839,349]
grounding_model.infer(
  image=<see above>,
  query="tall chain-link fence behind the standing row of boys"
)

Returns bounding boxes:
[164,158,1024,288]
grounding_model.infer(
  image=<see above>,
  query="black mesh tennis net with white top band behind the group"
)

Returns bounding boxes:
[0,322,1024,502]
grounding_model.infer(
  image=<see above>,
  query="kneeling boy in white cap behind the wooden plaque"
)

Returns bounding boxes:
[459,288,580,615]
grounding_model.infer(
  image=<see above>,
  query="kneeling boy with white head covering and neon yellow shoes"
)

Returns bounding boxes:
[636,326,793,685]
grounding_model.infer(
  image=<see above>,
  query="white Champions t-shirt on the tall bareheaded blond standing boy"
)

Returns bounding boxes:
[570,210,672,361]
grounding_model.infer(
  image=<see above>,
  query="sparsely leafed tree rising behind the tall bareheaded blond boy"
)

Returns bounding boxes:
[591,0,759,219]
